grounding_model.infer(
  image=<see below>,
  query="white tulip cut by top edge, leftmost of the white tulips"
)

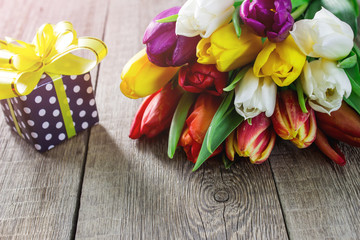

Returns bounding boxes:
[175,0,235,38]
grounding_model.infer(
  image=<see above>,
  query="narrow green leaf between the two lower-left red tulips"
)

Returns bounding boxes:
[168,92,196,159]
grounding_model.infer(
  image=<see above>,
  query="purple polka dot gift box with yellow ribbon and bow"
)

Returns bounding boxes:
[0,22,107,152]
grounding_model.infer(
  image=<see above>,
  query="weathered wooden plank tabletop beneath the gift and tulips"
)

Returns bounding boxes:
[0,0,360,239]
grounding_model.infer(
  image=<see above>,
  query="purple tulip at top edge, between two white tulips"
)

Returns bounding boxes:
[240,0,294,42]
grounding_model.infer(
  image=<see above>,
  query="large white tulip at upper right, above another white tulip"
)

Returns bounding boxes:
[290,8,354,60]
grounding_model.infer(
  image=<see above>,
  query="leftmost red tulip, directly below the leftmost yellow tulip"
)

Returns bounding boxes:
[129,82,183,139]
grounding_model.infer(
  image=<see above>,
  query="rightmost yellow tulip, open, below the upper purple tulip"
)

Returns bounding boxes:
[254,36,306,87]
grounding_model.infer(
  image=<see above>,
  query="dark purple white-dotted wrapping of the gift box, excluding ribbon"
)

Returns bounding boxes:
[0,73,99,152]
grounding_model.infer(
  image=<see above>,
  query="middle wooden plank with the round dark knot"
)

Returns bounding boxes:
[76,0,287,239]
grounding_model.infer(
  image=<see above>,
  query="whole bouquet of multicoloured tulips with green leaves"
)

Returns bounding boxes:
[120,0,360,170]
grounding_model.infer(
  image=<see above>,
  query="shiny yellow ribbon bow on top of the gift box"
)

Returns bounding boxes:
[0,22,107,99]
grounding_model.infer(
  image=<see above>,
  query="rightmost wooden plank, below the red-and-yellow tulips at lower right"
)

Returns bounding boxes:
[271,141,360,239]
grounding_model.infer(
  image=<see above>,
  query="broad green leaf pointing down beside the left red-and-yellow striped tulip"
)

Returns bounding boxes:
[193,92,243,171]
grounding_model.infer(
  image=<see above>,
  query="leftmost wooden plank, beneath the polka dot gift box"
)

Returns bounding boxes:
[0,0,107,239]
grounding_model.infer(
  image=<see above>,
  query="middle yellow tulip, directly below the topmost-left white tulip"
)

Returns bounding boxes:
[196,23,263,72]
